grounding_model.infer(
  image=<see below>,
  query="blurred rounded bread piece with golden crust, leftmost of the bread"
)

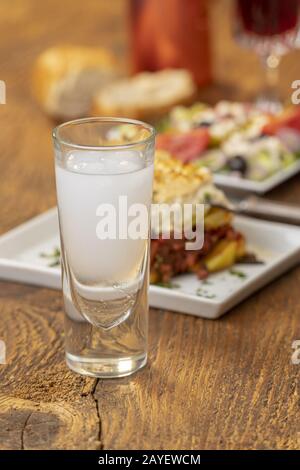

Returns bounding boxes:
[33,46,119,119]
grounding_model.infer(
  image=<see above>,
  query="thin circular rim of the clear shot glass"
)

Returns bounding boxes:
[52,116,156,150]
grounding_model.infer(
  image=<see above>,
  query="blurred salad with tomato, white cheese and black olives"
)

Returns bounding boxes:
[157,101,300,181]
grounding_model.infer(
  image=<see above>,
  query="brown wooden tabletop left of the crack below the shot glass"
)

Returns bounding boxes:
[0,282,100,449]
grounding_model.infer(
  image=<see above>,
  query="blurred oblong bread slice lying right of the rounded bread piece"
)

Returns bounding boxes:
[93,69,196,119]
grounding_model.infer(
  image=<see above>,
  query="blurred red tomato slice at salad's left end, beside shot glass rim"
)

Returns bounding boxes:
[156,129,209,163]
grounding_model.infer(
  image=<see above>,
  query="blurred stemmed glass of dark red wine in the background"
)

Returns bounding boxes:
[234,0,300,112]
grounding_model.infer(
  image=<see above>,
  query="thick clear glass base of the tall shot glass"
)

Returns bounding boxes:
[66,352,147,379]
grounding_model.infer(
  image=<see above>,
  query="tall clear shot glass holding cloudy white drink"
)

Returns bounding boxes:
[53,118,155,377]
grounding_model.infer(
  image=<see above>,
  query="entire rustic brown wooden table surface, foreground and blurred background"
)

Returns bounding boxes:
[0,0,300,449]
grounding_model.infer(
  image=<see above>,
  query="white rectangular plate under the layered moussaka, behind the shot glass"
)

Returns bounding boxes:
[0,208,300,318]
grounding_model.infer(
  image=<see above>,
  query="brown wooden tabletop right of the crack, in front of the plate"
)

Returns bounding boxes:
[96,276,300,449]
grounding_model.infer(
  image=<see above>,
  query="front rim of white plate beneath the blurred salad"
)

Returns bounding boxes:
[214,160,300,194]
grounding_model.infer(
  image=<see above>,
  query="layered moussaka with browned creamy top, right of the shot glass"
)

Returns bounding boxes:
[150,150,246,283]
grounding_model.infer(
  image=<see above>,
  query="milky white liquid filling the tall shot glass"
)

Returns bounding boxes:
[56,151,153,285]
